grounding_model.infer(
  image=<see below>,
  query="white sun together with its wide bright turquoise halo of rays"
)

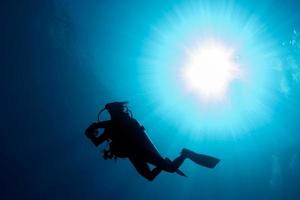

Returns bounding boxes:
[139,1,284,137]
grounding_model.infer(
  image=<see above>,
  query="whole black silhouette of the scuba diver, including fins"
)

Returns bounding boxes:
[85,102,220,181]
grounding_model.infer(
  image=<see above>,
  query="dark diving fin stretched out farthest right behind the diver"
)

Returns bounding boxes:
[182,149,220,168]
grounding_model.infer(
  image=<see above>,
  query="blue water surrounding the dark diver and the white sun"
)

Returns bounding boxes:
[0,0,300,200]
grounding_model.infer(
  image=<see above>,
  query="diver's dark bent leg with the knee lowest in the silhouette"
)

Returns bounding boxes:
[129,157,162,181]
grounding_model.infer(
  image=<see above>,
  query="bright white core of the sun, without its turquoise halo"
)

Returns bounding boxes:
[181,40,241,101]
